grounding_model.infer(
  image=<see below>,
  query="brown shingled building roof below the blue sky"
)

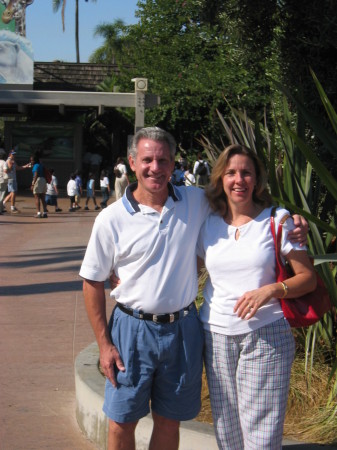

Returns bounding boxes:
[33,61,119,91]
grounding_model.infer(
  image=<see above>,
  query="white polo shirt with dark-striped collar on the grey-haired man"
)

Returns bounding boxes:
[80,184,209,314]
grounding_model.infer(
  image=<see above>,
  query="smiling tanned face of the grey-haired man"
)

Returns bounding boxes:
[129,139,174,194]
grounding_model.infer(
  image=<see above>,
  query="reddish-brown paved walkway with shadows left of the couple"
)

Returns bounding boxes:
[0,192,336,450]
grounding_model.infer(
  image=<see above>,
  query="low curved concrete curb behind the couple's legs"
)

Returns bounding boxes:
[75,342,218,450]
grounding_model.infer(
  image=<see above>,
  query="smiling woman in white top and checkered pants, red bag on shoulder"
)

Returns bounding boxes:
[198,145,316,450]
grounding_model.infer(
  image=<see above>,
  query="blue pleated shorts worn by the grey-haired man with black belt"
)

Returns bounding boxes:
[103,306,204,423]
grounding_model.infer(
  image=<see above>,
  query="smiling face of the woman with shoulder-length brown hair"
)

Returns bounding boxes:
[222,155,256,209]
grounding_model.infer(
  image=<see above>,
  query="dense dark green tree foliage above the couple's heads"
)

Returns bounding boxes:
[87,0,337,167]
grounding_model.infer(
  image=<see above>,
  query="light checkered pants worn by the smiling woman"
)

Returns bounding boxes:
[205,319,295,450]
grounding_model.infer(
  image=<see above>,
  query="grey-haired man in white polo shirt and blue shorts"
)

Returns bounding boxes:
[80,127,306,450]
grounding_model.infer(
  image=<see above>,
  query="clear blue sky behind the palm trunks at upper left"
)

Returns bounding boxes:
[26,0,137,63]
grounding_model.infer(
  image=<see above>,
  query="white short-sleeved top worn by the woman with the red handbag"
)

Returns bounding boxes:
[198,208,306,335]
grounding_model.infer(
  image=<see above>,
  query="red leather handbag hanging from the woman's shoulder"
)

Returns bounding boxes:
[270,208,331,328]
